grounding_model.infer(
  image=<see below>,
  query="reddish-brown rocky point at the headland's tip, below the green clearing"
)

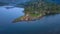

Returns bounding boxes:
[13,14,44,23]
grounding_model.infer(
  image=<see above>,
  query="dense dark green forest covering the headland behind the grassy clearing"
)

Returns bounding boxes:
[18,0,60,13]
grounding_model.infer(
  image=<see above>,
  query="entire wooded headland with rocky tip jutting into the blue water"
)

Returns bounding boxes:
[13,0,60,22]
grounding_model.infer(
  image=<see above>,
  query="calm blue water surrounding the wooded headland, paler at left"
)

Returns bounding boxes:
[0,7,60,34]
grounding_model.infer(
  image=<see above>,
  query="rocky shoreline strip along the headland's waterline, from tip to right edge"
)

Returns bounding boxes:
[13,13,59,23]
